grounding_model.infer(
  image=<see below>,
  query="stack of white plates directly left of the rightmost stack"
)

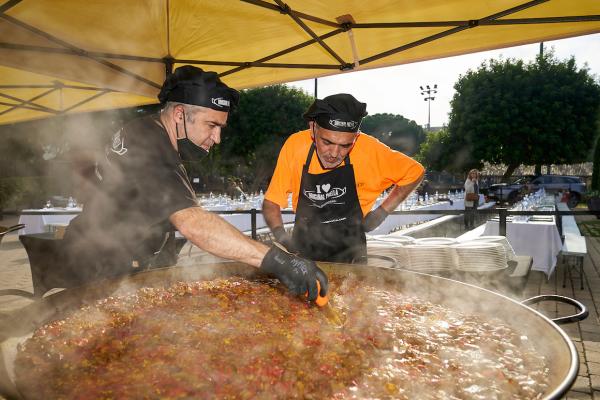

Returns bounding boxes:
[404,244,454,273]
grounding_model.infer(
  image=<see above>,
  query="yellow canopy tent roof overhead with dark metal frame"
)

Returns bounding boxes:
[0,0,600,123]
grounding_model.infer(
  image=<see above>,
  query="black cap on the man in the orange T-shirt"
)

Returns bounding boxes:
[304,93,368,132]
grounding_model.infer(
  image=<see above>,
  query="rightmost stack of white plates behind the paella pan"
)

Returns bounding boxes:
[451,242,507,272]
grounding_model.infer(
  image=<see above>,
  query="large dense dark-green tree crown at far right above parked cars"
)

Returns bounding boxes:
[446,52,600,179]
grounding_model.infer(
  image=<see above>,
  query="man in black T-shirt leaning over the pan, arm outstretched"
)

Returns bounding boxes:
[63,65,328,301]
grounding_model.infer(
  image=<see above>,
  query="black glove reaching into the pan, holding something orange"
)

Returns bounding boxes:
[260,244,329,301]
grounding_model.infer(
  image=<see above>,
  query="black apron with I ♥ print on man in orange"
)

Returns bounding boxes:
[292,143,367,263]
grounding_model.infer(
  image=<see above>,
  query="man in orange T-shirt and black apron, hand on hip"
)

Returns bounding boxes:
[262,94,425,262]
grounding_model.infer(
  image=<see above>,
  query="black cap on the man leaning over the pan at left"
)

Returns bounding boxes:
[158,65,240,112]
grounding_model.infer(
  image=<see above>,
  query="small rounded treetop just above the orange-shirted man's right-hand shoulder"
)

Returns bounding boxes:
[361,113,425,156]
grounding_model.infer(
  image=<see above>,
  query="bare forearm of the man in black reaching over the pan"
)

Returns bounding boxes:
[169,207,269,267]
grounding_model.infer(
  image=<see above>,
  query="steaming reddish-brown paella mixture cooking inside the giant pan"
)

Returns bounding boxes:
[15,275,548,399]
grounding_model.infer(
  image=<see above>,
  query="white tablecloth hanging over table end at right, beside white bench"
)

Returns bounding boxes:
[483,217,562,278]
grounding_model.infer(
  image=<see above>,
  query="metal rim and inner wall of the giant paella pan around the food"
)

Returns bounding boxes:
[0,262,579,399]
